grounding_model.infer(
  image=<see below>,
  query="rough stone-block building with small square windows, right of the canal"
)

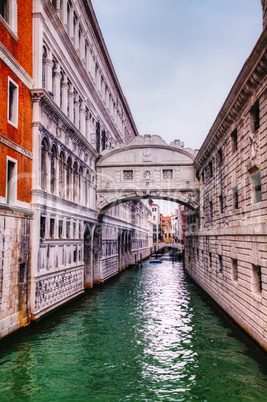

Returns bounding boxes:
[185,1,267,349]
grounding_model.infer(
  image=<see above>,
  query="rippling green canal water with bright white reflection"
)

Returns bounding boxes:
[0,261,267,402]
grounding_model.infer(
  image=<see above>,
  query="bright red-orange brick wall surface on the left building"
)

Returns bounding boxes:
[0,0,32,202]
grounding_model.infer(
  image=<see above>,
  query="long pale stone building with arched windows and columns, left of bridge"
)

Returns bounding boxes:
[31,0,151,318]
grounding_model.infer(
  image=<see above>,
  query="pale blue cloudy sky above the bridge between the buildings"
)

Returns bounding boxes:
[92,0,262,214]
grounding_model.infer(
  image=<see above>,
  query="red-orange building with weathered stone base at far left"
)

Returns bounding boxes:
[0,0,33,338]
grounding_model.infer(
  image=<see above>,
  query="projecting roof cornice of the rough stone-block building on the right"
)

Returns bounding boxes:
[195,30,267,169]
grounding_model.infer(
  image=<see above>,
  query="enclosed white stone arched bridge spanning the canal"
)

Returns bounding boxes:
[96,134,200,216]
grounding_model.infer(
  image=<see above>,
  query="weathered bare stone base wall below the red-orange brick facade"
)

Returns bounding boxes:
[0,210,31,338]
